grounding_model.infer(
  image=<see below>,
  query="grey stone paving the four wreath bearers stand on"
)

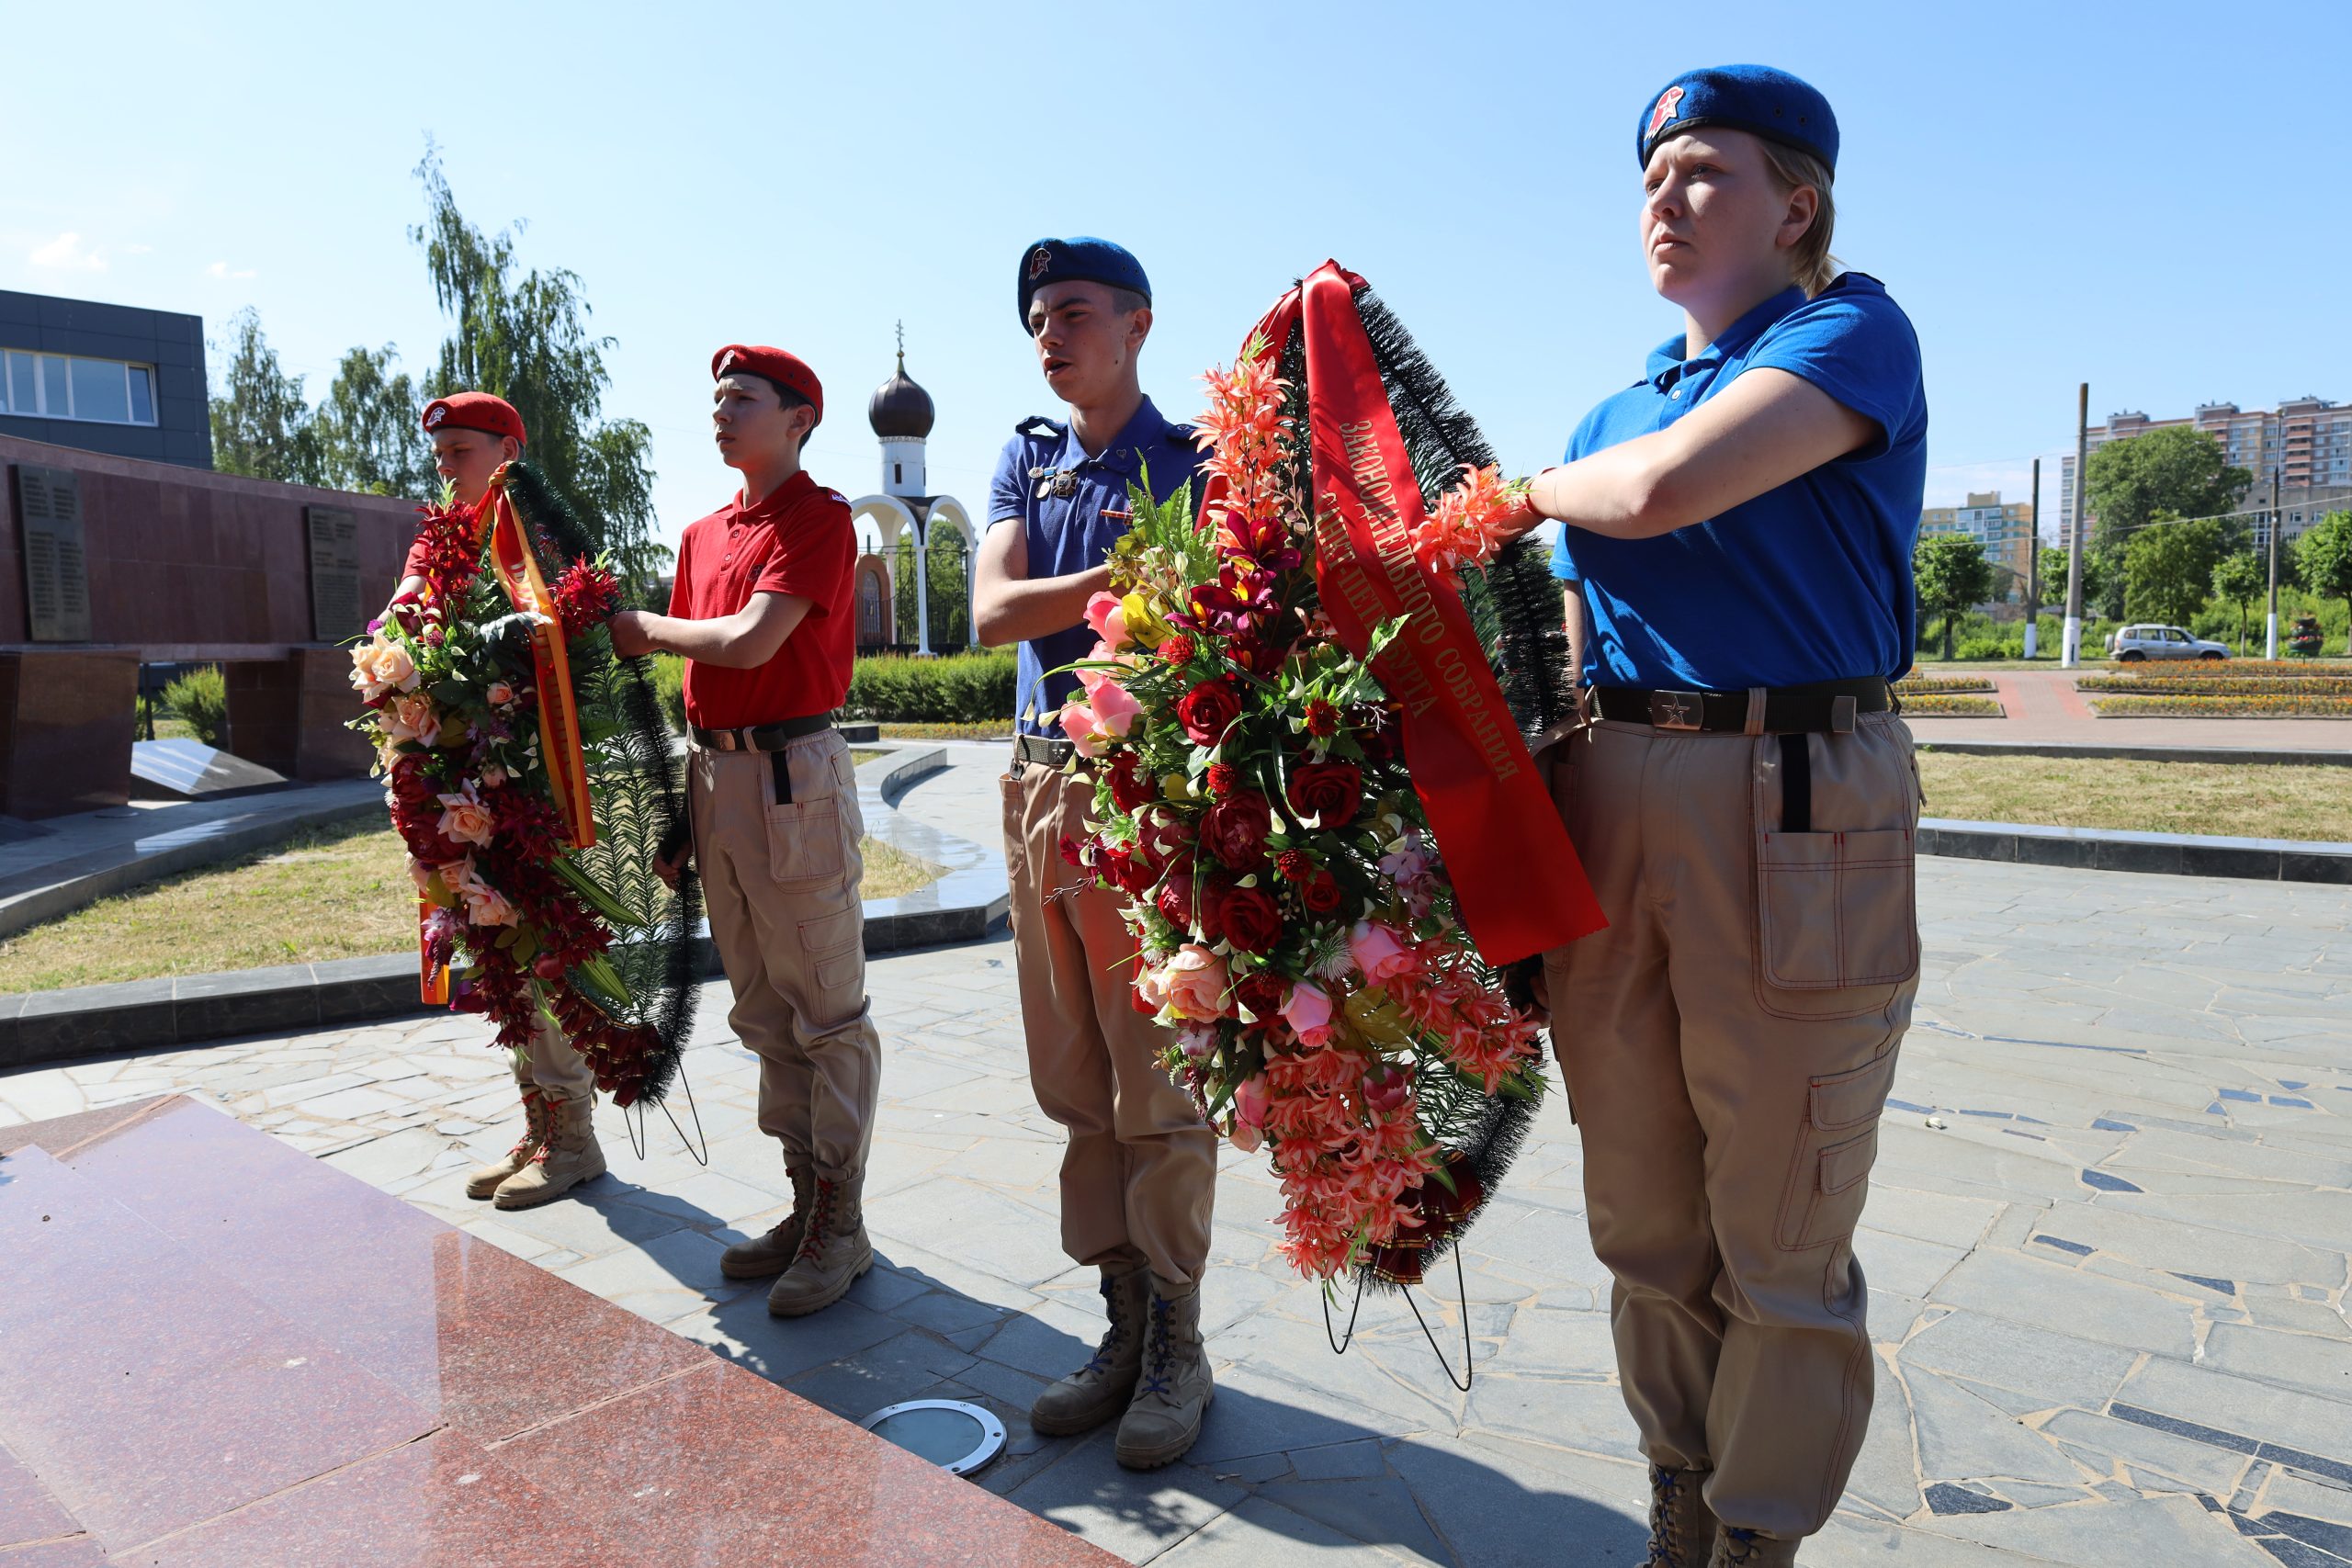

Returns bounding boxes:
[0,752,2352,1568]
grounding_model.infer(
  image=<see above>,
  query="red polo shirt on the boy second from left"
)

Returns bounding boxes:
[671,470,858,728]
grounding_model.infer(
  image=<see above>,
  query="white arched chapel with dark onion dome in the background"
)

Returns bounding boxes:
[849,332,978,656]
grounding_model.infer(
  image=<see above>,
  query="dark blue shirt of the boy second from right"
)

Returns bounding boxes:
[988,398,1204,736]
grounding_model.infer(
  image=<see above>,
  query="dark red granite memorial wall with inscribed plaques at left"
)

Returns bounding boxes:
[0,437,416,818]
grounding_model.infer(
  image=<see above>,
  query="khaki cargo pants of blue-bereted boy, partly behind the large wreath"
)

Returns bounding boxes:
[1002,761,1216,1283]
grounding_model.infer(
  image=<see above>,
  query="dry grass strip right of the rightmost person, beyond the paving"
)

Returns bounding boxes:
[1919,745,2352,841]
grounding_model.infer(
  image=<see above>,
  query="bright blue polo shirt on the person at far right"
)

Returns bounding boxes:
[1553,273,1927,691]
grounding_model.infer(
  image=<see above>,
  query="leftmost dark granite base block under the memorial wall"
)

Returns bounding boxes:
[0,649,137,818]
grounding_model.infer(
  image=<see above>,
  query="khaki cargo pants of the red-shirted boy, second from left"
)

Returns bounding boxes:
[687,728,882,1182]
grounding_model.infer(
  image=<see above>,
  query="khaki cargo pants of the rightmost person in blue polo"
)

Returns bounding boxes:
[1545,715,1919,1538]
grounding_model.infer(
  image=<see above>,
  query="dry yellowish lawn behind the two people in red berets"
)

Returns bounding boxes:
[0,818,941,995]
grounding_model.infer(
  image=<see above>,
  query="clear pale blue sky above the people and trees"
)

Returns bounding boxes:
[0,0,2352,557]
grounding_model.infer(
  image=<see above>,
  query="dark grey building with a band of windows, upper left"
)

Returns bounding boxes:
[0,289,211,468]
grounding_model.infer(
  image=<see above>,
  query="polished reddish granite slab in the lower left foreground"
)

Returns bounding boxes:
[0,1096,1117,1568]
